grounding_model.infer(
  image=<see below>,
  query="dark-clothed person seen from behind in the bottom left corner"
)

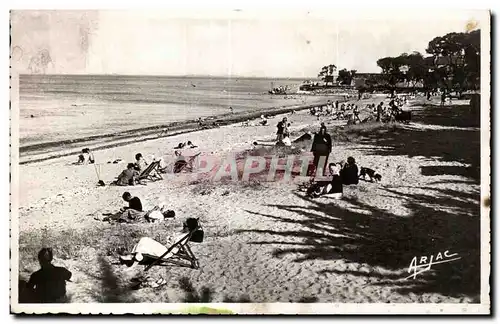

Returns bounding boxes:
[26,248,72,303]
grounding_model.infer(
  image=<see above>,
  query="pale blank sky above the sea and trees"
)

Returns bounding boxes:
[11,10,484,77]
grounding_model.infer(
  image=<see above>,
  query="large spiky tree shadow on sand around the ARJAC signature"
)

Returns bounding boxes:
[238,188,480,296]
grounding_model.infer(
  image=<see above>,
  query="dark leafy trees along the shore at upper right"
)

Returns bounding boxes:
[358,30,481,95]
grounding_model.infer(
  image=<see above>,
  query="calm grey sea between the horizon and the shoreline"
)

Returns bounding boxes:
[19,75,317,146]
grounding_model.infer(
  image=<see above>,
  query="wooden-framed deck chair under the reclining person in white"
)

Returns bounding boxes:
[144,226,203,271]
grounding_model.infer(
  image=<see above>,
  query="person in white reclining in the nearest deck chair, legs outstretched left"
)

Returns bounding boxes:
[119,218,198,267]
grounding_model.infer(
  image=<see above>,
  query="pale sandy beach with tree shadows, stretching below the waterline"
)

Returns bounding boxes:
[19,98,480,303]
